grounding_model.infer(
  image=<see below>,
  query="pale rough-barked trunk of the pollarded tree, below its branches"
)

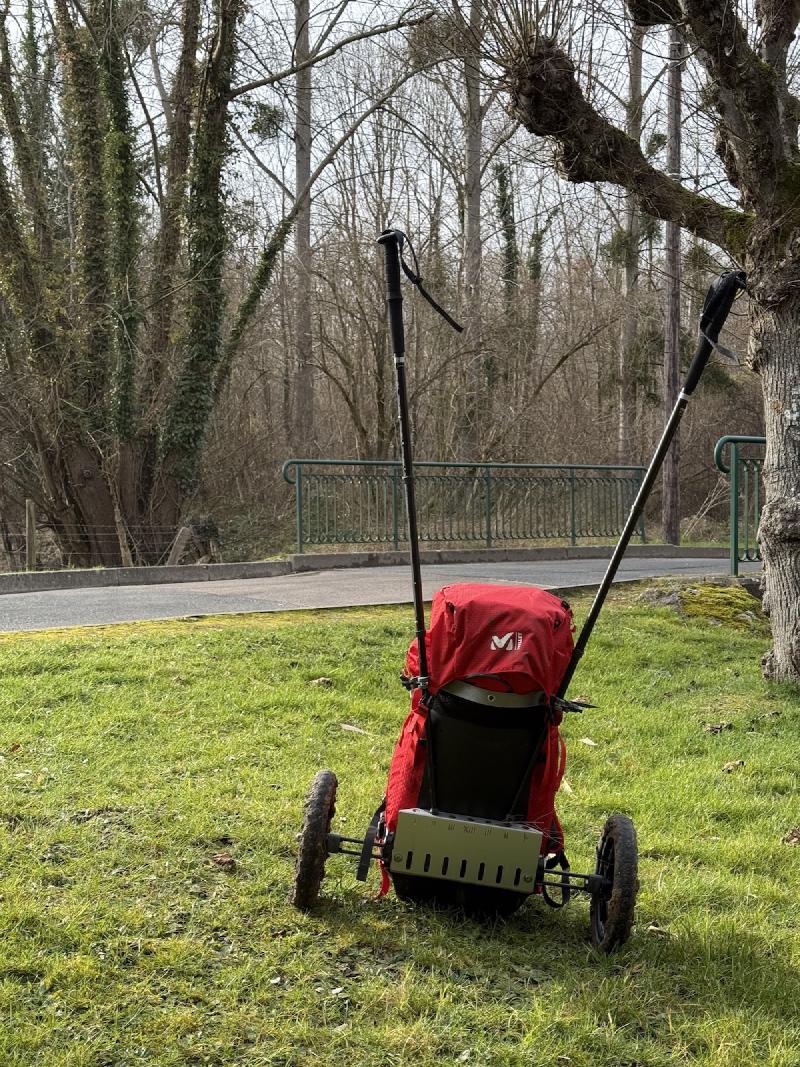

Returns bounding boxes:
[750,297,800,680]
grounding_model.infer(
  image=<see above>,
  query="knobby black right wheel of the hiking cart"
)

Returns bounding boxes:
[589,815,639,952]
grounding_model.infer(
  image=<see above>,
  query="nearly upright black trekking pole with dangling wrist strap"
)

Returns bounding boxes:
[378,229,462,692]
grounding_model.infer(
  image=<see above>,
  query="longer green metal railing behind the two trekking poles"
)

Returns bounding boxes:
[283,460,645,552]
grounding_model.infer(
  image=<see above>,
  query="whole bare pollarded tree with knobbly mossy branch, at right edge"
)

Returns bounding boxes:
[501,0,800,680]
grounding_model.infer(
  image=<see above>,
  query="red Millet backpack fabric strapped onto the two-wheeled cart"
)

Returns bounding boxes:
[383,583,574,866]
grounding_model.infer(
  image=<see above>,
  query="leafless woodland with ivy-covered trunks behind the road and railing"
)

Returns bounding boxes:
[0,0,763,564]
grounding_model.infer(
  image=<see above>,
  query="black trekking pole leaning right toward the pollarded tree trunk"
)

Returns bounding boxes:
[557,271,746,699]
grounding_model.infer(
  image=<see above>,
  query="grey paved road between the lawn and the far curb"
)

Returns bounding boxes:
[0,558,757,632]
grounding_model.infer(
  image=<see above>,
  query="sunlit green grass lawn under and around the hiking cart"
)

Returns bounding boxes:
[0,590,800,1067]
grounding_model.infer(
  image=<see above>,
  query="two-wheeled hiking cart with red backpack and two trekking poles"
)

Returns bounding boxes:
[291,229,745,952]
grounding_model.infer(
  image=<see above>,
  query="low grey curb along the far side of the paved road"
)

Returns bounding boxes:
[0,544,727,595]
